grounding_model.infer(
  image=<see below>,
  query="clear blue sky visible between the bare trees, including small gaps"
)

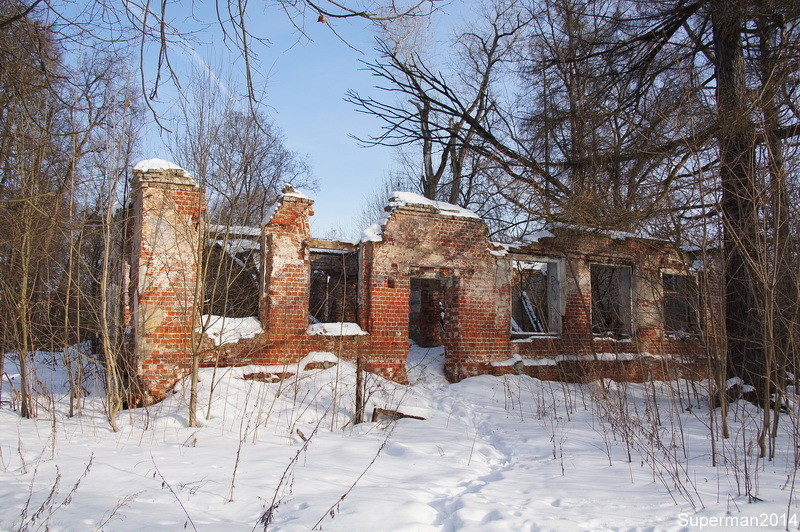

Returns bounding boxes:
[144,3,472,237]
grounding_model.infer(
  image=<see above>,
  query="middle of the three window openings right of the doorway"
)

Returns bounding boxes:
[591,264,631,338]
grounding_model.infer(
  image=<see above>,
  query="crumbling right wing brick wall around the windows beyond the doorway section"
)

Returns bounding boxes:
[500,227,717,380]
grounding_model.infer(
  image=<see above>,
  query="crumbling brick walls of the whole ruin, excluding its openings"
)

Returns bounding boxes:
[123,162,713,398]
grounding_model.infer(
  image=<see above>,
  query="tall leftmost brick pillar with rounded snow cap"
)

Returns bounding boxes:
[129,159,205,402]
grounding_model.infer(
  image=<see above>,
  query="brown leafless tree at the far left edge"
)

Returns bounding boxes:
[0,6,72,417]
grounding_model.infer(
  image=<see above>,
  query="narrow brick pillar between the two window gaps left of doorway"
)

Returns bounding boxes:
[259,185,314,338]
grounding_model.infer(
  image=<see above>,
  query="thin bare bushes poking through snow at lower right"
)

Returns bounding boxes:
[502,368,800,515]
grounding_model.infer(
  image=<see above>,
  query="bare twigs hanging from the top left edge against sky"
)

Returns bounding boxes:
[0,0,437,125]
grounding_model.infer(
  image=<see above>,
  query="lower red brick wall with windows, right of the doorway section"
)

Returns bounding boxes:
[504,228,706,380]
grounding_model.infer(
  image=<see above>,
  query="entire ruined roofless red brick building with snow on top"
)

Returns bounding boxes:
[122,160,719,400]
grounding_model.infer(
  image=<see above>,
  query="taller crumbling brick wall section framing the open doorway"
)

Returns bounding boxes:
[362,204,510,379]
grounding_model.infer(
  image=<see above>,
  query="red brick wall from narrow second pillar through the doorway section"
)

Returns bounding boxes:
[216,198,511,382]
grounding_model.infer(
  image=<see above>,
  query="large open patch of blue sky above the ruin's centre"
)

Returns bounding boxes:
[260,16,394,236]
